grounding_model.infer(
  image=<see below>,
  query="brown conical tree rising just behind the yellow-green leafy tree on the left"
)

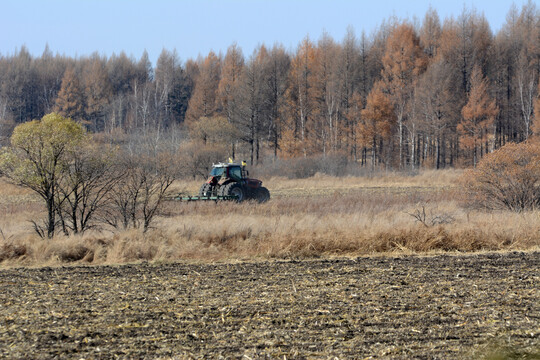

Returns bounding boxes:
[55,66,85,121]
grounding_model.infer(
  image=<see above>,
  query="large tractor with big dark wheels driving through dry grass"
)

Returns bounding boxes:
[199,162,270,203]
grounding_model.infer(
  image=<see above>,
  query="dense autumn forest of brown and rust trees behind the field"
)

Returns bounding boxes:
[0,1,540,169]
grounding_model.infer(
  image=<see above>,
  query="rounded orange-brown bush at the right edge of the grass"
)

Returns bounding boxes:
[464,141,540,212]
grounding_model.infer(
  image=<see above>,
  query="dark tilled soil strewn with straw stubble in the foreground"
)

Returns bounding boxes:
[0,252,540,359]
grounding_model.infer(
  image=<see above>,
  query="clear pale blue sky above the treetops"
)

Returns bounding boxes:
[0,0,524,65]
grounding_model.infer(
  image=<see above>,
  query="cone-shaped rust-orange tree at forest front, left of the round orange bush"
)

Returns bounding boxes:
[457,65,499,167]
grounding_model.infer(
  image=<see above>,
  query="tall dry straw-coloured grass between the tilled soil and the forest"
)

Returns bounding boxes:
[0,171,540,266]
